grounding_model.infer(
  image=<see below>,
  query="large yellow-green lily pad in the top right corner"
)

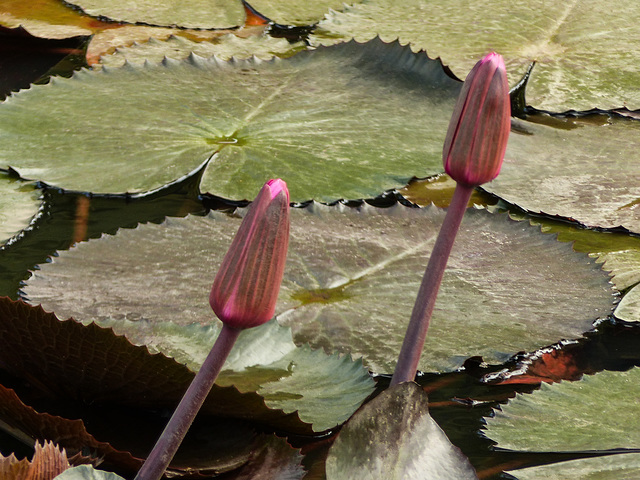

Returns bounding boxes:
[311,0,640,111]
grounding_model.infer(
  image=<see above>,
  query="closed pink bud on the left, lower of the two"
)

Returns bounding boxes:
[209,179,289,329]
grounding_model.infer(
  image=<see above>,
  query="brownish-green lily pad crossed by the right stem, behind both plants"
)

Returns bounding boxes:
[25,203,615,373]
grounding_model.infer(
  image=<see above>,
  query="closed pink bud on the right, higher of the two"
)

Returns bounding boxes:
[442,53,511,186]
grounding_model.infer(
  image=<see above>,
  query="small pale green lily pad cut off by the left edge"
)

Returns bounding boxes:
[0,172,41,244]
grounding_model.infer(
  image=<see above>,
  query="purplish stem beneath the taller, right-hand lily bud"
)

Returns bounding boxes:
[391,183,474,385]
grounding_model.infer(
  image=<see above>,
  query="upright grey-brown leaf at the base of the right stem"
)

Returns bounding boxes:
[327,383,478,480]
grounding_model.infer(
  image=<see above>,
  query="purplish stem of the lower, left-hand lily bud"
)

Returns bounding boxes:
[135,325,241,480]
